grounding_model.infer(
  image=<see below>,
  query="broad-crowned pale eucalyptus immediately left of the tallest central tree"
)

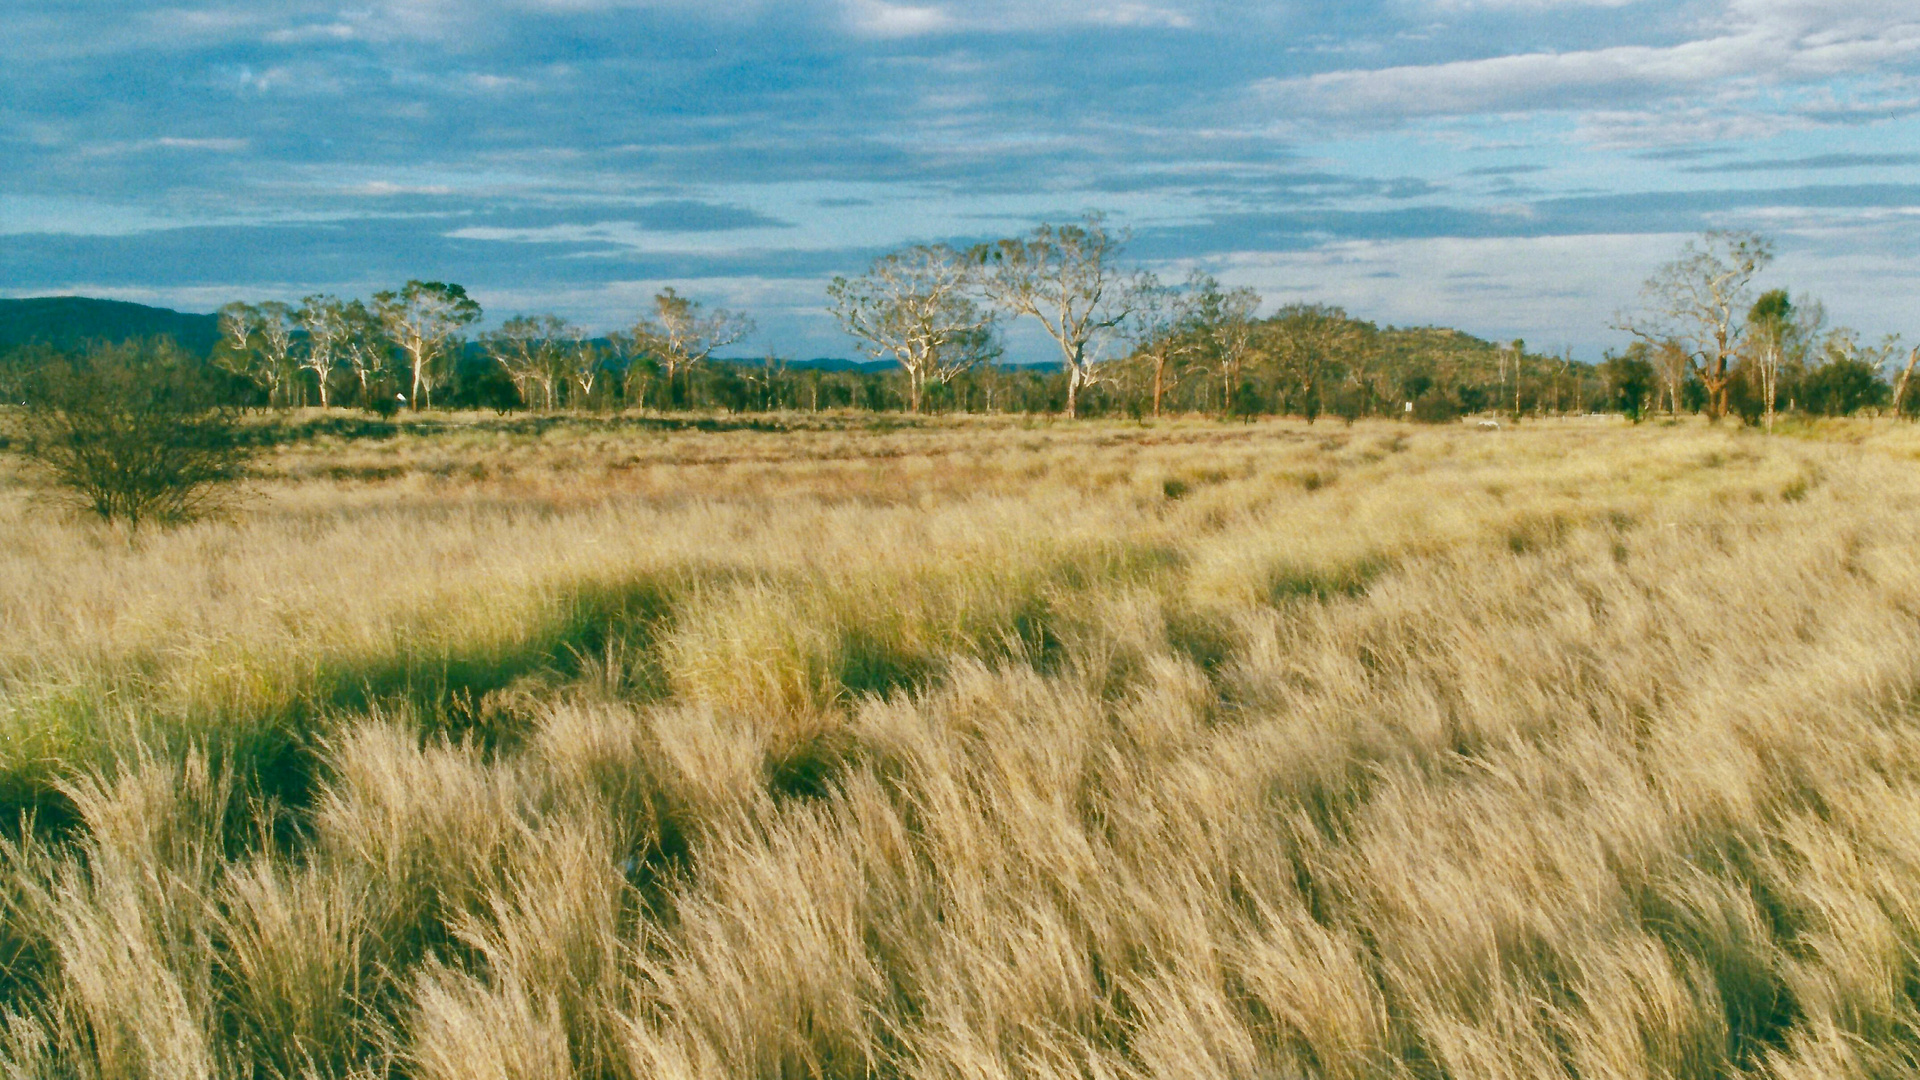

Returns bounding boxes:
[828,244,1000,413]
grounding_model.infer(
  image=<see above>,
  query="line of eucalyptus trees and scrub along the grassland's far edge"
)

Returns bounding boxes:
[0,213,1920,427]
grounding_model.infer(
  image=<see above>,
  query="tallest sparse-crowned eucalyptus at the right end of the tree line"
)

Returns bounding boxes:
[1619,231,1774,419]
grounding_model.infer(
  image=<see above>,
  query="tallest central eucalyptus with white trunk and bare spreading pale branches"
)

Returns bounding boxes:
[970,213,1140,417]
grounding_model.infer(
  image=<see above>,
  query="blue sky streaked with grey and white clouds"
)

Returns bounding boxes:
[0,0,1920,359]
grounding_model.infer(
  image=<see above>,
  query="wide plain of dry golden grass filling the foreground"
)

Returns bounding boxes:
[0,405,1920,1080]
